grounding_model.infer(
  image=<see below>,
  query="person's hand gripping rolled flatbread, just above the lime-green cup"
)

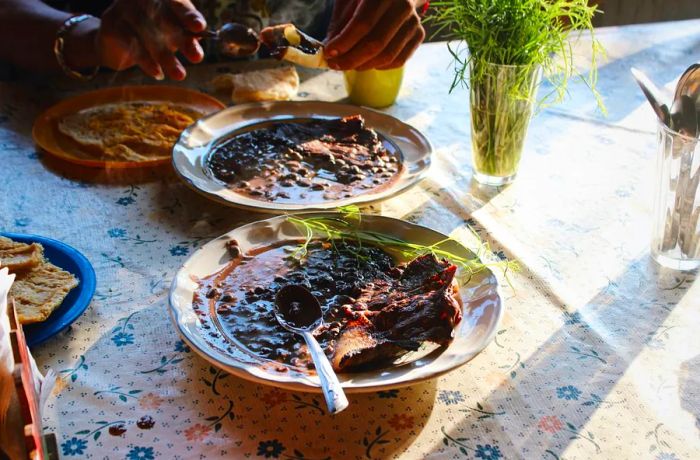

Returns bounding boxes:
[324,0,425,70]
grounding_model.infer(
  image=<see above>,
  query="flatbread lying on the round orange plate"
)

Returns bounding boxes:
[58,101,202,161]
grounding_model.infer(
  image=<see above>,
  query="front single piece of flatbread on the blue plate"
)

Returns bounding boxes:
[10,261,78,324]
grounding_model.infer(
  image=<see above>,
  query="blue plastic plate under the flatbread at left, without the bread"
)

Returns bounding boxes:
[0,232,96,347]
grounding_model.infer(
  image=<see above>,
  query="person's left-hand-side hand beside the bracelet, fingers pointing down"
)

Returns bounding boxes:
[96,0,207,80]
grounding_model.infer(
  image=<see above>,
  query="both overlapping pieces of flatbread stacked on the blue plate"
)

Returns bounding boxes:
[0,236,78,324]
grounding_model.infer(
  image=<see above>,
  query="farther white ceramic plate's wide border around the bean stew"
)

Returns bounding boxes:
[173,101,432,213]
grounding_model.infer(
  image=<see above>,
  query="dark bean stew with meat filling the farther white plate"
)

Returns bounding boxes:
[207,116,402,204]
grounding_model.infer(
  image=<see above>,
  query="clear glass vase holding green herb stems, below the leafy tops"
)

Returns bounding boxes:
[469,63,542,186]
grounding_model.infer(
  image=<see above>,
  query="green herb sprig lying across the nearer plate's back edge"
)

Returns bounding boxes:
[287,206,520,284]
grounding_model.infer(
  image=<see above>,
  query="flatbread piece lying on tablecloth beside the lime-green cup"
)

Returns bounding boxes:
[212,65,299,104]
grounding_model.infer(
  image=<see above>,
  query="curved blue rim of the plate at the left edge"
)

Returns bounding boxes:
[0,231,97,347]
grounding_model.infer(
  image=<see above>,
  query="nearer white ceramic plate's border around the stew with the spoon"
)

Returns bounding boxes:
[170,213,503,392]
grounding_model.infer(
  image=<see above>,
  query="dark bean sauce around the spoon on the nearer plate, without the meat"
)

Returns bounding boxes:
[195,242,396,368]
